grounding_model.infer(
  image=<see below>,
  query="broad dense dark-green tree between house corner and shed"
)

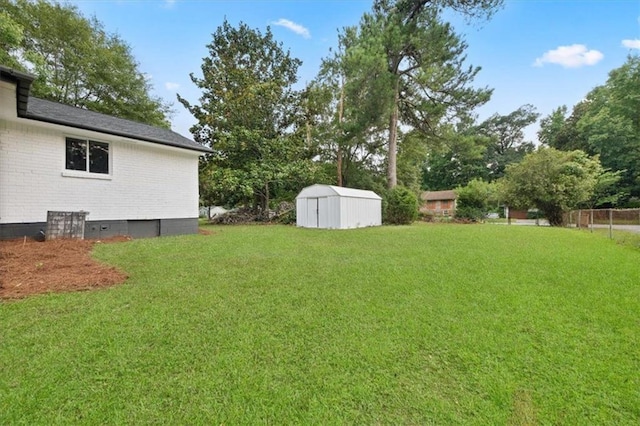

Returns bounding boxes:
[178,20,317,212]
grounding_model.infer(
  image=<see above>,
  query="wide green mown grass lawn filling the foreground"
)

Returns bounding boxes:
[0,224,640,425]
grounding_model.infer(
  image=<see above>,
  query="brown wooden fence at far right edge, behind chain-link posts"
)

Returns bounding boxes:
[565,209,640,238]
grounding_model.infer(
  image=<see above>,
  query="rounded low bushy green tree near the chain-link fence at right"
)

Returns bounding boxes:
[501,148,603,226]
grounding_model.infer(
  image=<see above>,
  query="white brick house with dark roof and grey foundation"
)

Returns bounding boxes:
[0,66,210,239]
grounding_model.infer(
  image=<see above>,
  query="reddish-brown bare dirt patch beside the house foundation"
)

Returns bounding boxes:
[0,237,129,299]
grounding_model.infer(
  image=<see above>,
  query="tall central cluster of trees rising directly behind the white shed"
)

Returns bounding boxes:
[179,0,502,211]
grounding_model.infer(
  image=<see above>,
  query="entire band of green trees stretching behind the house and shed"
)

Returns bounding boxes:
[5,0,640,224]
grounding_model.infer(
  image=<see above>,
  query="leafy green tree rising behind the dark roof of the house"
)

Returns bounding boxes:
[0,0,171,127]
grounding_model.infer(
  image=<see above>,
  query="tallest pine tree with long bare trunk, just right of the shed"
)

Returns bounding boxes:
[347,0,502,188]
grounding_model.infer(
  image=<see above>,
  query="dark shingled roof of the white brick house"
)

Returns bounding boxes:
[0,66,212,152]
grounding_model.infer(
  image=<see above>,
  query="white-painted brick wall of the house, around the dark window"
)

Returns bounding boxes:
[0,87,198,223]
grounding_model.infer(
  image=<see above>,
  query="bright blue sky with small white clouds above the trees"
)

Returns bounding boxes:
[71,0,640,140]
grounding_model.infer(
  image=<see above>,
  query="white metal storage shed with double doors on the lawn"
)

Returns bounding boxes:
[296,185,382,229]
